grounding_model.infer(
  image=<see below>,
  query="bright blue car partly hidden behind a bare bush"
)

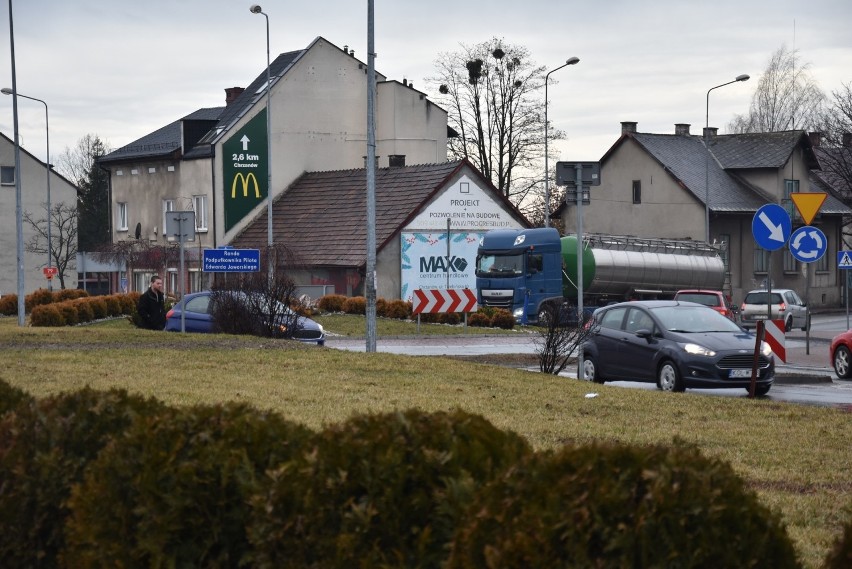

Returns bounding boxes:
[165,291,325,346]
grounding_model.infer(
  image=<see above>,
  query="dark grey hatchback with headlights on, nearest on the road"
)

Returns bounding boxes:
[583,300,775,395]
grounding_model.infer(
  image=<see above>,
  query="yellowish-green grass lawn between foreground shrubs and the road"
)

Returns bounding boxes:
[0,316,852,568]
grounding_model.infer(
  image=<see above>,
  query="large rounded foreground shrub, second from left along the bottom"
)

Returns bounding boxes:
[63,403,312,567]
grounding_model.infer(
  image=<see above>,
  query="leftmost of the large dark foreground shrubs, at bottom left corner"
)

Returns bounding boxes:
[0,388,163,567]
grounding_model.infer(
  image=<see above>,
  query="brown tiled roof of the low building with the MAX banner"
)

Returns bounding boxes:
[231,161,522,267]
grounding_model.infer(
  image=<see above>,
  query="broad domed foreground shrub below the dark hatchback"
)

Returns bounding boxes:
[447,443,800,569]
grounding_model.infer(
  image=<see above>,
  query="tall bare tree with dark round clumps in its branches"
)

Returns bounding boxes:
[427,38,564,214]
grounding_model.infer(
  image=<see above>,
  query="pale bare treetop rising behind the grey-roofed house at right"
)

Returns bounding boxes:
[728,45,825,133]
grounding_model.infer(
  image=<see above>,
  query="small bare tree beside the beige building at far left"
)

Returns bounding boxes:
[23,202,77,289]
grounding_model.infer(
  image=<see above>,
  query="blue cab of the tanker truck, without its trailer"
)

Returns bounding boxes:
[476,227,562,324]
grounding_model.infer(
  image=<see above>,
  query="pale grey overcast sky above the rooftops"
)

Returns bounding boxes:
[0,0,852,171]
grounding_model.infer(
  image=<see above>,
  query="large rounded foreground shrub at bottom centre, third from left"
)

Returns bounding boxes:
[249,410,530,569]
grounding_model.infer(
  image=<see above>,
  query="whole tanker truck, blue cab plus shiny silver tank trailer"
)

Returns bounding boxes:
[476,228,725,323]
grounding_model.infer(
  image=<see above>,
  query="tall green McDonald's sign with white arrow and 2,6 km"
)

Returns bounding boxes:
[222,109,269,231]
